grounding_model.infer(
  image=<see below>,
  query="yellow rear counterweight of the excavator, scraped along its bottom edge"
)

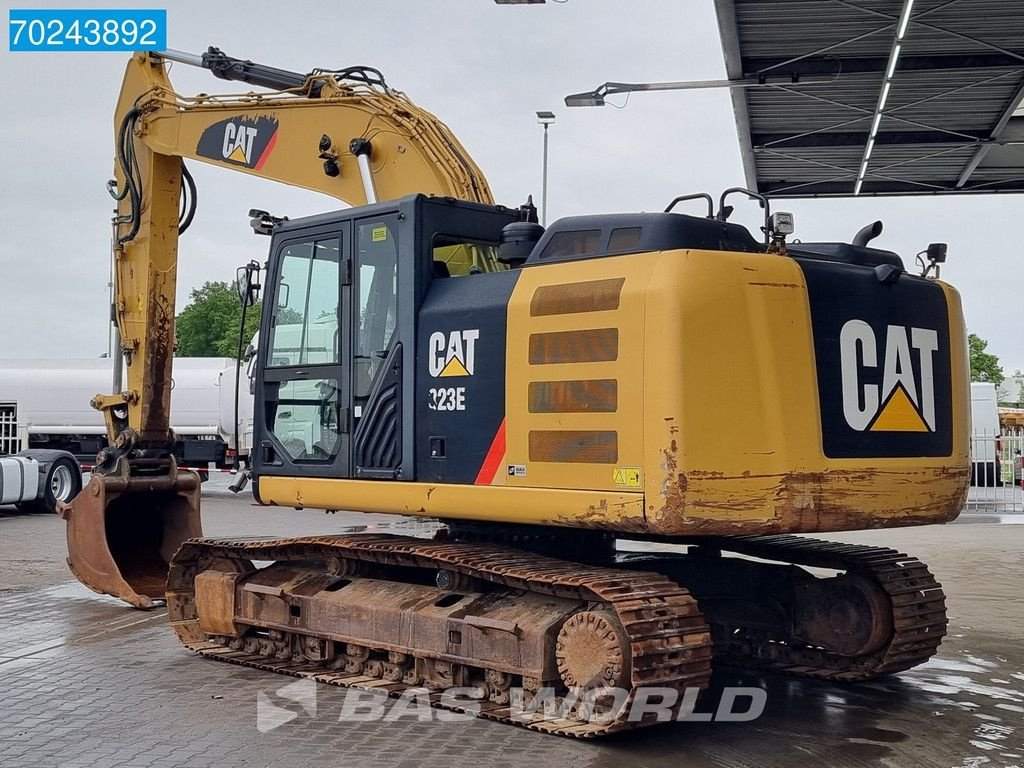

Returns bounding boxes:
[645,251,969,535]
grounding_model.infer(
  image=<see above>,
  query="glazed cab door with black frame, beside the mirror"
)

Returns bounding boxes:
[254,222,352,477]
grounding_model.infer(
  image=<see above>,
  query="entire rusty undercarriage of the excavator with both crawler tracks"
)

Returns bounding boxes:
[168,527,946,737]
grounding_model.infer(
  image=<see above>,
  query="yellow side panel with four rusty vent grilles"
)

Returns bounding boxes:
[505,254,655,492]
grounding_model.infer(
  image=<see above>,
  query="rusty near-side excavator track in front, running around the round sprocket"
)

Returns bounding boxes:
[167,535,712,738]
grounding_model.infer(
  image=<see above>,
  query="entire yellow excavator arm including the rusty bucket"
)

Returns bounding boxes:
[61,48,492,607]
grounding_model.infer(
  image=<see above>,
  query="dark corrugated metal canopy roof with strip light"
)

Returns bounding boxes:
[715,0,1024,198]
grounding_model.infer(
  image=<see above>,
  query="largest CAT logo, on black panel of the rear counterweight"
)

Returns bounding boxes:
[839,319,939,432]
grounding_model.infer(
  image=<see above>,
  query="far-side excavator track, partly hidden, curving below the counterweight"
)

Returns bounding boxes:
[700,536,947,682]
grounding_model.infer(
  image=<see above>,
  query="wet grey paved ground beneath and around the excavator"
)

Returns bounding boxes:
[0,489,1024,768]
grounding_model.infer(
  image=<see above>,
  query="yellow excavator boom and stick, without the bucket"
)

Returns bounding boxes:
[107,51,492,443]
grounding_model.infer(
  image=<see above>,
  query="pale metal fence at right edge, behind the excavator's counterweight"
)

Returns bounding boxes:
[967,427,1024,513]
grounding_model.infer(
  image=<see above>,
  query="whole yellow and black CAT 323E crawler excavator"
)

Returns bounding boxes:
[61,48,970,737]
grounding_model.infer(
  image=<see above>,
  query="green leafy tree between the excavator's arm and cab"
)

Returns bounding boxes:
[175,282,260,357]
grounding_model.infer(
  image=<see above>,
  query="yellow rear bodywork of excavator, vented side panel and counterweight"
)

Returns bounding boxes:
[491,250,970,536]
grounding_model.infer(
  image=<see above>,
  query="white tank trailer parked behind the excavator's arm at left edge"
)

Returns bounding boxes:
[0,357,252,468]
